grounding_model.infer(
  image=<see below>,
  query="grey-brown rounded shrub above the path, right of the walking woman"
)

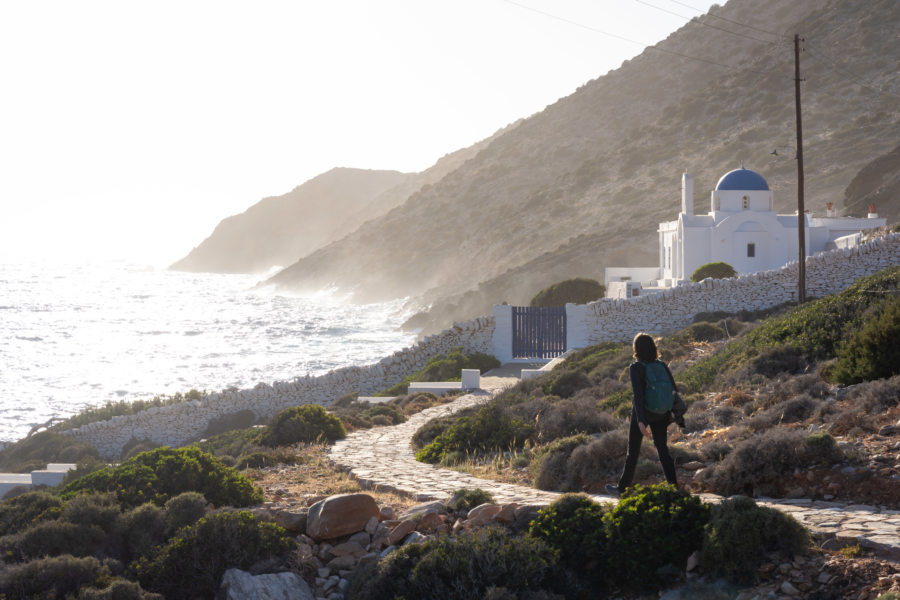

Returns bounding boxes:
[703,428,842,496]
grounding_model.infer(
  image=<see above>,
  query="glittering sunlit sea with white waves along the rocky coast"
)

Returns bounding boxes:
[0,263,415,441]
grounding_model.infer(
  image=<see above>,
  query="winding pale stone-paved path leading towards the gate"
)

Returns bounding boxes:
[329,365,900,558]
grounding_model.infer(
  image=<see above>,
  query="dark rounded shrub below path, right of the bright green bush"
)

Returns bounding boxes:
[701,496,811,585]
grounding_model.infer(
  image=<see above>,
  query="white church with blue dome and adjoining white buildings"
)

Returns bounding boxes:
[605,167,885,298]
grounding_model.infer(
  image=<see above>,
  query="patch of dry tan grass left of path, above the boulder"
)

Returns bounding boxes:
[245,444,417,509]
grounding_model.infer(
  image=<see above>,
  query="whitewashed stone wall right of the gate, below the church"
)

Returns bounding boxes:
[567,233,900,348]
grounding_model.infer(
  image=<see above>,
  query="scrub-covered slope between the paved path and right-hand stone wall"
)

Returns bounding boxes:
[414,267,900,508]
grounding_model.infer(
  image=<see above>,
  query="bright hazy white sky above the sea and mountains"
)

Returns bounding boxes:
[0,0,712,266]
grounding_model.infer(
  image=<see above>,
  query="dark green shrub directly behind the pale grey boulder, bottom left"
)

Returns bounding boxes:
[132,511,295,600]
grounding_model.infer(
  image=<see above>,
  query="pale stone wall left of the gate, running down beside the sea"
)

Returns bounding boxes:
[65,317,494,459]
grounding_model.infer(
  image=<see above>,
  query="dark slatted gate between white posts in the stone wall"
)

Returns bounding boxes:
[512,306,566,358]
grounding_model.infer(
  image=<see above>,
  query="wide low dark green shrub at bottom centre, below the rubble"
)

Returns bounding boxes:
[347,528,558,600]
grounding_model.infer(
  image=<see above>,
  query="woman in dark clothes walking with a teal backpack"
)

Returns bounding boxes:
[606,333,680,496]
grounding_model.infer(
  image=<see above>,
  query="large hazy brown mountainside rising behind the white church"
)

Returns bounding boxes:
[262,0,900,326]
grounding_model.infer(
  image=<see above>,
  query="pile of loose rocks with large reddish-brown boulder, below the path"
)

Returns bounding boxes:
[250,493,540,600]
